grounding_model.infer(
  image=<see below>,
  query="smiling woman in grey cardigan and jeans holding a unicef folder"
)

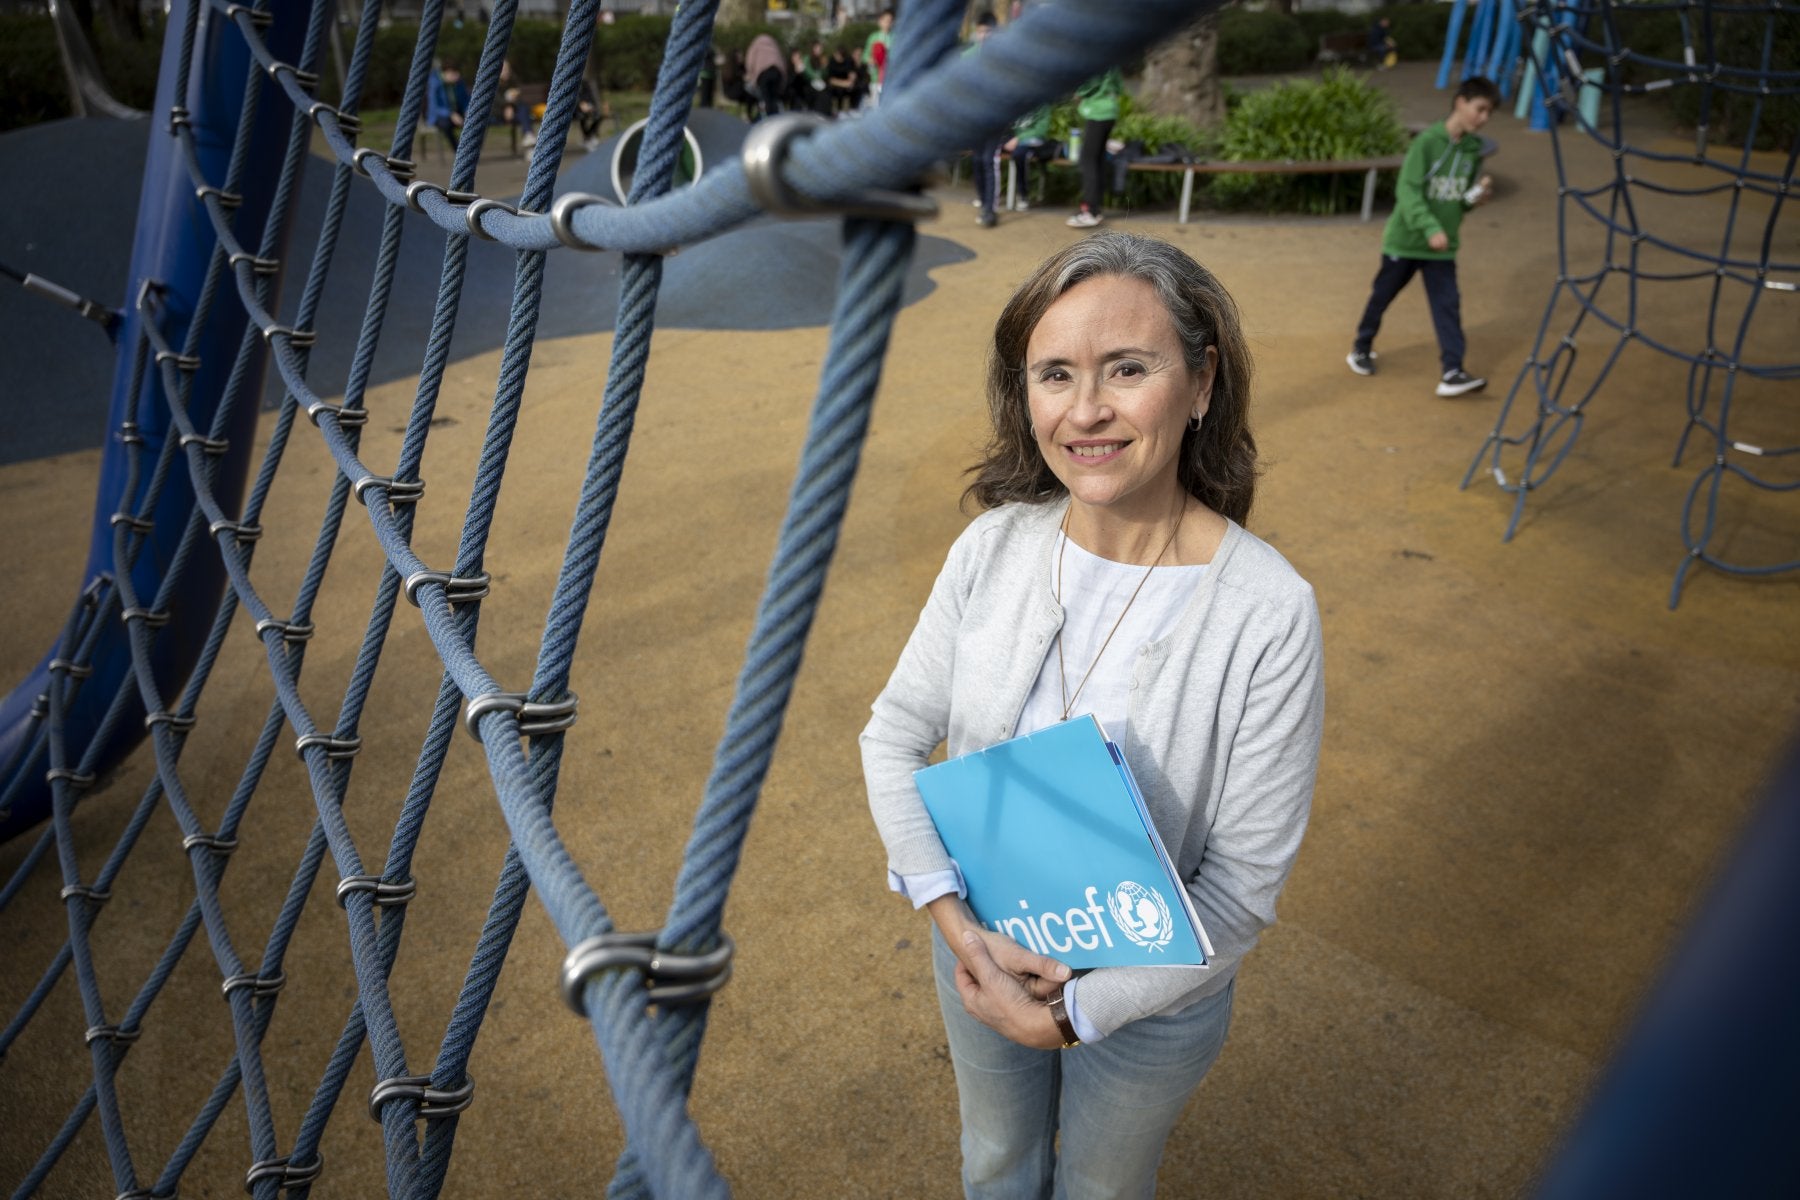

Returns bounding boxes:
[862,234,1323,1198]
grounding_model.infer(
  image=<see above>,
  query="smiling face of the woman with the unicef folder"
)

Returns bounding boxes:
[1024,275,1219,518]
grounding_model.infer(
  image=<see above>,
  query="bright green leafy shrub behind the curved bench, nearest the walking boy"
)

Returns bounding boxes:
[1210,68,1406,212]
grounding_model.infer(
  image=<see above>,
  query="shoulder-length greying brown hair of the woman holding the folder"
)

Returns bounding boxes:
[963,232,1256,524]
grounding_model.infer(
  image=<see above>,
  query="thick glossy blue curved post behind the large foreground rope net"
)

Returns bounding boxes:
[0,0,310,840]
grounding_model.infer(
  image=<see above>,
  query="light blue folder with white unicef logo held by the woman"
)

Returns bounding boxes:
[913,716,1211,970]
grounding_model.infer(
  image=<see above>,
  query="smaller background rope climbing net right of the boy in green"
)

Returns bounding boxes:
[1463,0,1800,608]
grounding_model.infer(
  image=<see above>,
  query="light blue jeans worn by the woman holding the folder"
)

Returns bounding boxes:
[931,927,1235,1200]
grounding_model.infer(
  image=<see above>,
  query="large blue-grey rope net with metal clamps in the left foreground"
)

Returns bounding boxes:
[0,0,1208,1200]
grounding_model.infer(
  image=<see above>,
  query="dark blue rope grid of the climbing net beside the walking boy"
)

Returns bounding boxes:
[1462,0,1800,608]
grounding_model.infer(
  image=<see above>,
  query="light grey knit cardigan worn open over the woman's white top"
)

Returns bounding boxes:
[862,502,1325,1034]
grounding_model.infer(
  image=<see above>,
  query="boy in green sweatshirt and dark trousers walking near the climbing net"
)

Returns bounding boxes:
[1345,76,1499,396]
